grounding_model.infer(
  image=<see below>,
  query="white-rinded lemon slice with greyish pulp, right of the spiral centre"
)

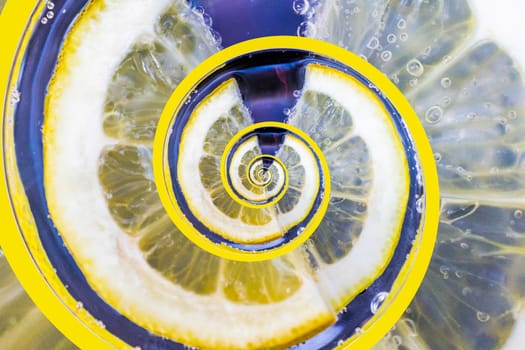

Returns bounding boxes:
[289,65,410,309]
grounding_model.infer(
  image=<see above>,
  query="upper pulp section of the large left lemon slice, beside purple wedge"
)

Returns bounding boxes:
[103,2,217,142]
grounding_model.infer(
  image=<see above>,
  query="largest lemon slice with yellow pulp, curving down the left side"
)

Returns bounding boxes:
[43,0,335,349]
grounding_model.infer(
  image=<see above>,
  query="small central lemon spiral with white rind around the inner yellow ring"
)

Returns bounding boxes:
[174,79,330,252]
